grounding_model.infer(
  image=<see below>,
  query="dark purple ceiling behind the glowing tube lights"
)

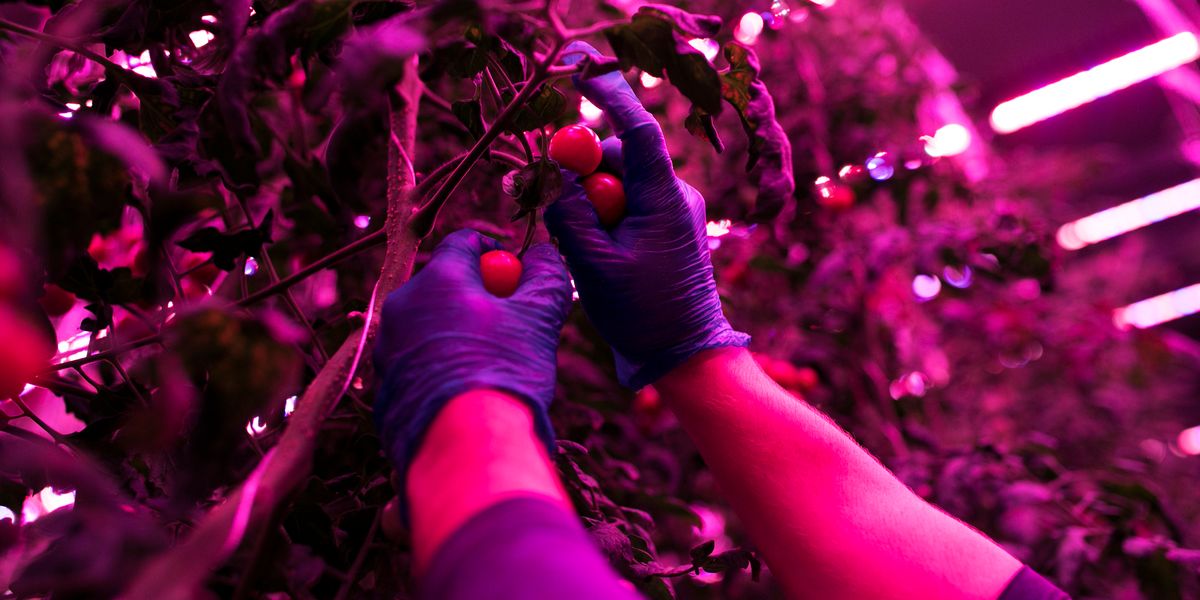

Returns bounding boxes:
[904,0,1200,338]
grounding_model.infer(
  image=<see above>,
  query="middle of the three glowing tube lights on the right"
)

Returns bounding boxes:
[1058,179,1200,250]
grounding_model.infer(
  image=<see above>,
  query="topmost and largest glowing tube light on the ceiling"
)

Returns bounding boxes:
[991,31,1200,133]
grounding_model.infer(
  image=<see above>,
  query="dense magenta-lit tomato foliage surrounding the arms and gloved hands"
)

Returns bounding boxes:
[0,0,1200,598]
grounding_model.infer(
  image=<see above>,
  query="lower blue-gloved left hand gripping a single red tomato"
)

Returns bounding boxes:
[374,229,571,506]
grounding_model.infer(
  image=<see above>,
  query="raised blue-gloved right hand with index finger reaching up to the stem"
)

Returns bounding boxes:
[546,42,750,389]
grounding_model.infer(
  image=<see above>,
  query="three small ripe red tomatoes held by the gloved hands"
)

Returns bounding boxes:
[480,125,625,298]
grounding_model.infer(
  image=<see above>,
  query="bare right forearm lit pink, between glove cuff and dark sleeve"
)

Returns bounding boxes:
[655,348,1020,599]
